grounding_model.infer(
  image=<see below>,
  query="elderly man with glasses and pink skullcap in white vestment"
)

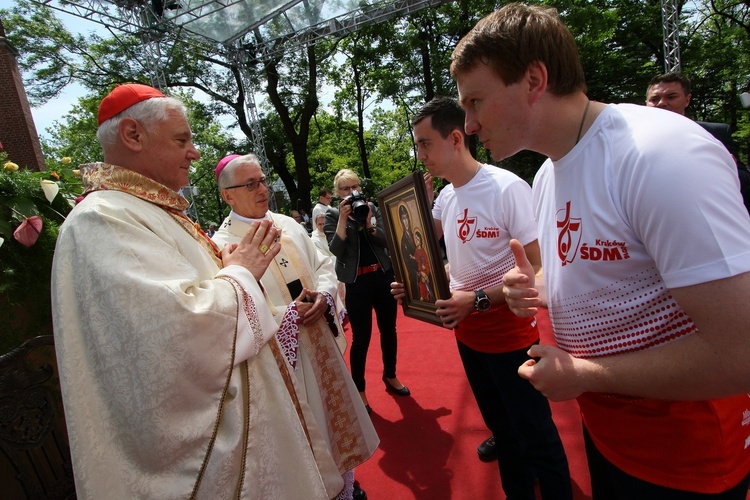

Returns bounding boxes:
[213,154,378,499]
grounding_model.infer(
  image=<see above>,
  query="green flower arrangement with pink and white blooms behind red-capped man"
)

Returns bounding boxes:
[0,150,81,353]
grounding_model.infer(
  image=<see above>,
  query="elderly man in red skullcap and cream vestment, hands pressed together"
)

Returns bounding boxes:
[52,84,370,499]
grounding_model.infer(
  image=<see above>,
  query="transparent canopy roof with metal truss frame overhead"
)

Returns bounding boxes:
[32,0,448,59]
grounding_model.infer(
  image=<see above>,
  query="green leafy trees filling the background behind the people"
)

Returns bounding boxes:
[3,0,750,191]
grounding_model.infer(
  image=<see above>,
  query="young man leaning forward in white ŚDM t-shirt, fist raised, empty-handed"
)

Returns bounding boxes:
[451,4,750,500]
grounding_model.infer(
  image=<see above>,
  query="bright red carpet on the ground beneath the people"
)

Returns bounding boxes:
[346,311,591,500]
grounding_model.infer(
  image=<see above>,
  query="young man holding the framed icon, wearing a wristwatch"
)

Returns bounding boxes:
[391,97,573,500]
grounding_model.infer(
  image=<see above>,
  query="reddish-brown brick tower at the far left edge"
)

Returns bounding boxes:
[0,20,45,170]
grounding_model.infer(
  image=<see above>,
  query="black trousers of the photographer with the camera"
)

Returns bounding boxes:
[346,269,398,392]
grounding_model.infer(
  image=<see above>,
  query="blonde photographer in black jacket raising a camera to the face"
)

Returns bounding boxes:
[323,169,411,412]
